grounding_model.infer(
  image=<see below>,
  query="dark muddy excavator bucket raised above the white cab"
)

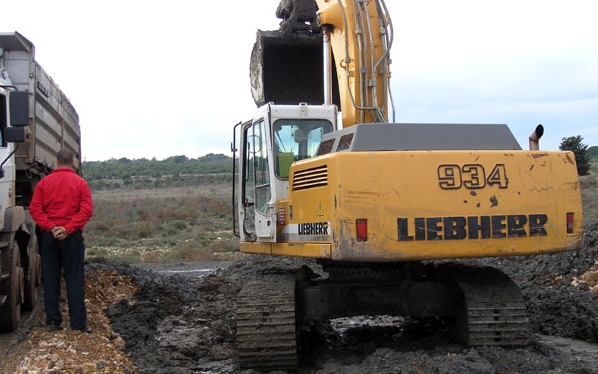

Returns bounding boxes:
[250,30,339,106]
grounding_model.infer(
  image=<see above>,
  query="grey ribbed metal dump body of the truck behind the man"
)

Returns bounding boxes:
[0,32,81,205]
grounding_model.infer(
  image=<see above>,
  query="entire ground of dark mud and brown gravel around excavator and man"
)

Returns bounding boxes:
[0,223,598,374]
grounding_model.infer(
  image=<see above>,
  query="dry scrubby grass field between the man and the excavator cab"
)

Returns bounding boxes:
[85,184,238,263]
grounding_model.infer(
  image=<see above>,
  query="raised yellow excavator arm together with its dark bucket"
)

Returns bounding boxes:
[250,0,393,127]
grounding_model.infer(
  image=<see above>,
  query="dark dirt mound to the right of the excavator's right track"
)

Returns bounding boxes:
[483,223,598,343]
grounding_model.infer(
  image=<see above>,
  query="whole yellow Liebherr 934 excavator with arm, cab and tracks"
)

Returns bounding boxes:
[232,0,582,371]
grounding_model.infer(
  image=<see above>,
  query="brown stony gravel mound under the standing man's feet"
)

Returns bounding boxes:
[0,265,139,374]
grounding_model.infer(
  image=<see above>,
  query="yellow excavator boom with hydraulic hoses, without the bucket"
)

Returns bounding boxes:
[316,0,392,127]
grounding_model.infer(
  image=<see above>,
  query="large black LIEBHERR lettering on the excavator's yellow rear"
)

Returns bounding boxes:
[397,214,548,241]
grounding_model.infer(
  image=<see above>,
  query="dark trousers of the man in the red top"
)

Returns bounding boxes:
[41,231,87,330]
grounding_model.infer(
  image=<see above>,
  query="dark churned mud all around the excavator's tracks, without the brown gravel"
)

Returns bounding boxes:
[102,224,598,374]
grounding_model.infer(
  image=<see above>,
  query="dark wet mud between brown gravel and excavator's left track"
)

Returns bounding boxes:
[107,256,314,373]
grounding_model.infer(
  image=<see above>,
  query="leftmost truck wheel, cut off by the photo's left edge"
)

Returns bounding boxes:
[0,241,24,332]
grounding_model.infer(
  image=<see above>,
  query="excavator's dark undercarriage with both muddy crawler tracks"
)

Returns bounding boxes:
[237,263,530,371]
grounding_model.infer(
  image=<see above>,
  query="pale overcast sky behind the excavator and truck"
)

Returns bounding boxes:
[0,0,598,161]
